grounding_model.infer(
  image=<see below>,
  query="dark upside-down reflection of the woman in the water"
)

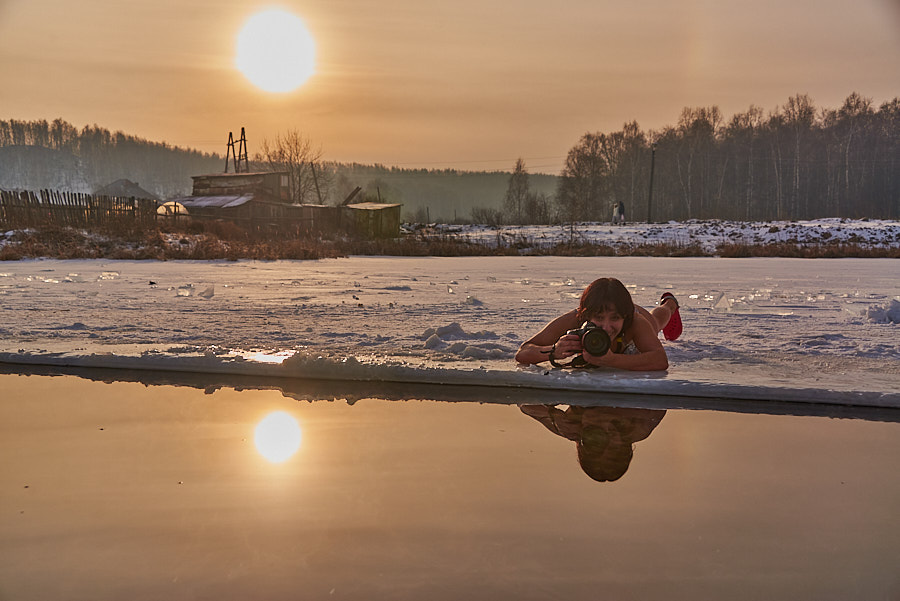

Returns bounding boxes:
[520,405,666,482]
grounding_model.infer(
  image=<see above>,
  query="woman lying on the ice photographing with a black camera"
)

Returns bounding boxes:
[516,278,681,371]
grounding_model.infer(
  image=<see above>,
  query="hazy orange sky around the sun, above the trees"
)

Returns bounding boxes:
[0,0,900,173]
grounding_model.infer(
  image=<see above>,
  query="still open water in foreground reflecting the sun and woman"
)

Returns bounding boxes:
[0,375,900,600]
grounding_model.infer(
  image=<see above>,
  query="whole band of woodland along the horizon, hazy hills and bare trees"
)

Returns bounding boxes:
[0,93,900,223]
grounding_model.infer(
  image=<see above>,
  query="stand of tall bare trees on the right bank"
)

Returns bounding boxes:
[552,93,900,222]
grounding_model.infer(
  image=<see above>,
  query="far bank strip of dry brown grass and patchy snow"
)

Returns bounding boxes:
[0,219,900,261]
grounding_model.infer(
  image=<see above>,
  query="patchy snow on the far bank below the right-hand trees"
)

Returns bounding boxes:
[418,219,900,254]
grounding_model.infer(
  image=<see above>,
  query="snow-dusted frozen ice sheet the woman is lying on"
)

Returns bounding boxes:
[0,257,900,406]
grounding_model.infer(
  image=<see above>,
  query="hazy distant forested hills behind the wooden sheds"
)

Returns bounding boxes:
[0,119,558,222]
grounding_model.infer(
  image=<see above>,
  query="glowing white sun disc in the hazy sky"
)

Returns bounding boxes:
[235,9,316,92]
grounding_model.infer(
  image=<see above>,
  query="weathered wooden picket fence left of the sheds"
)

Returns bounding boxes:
[0,190,156,228]
